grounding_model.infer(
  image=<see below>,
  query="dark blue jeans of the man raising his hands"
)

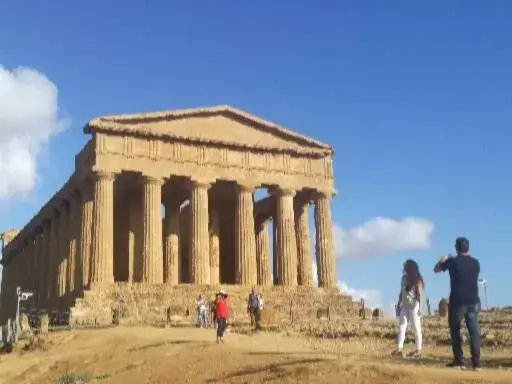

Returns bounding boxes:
[448,303,480,364]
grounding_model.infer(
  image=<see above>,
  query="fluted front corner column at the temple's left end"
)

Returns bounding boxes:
[91,172,115,283]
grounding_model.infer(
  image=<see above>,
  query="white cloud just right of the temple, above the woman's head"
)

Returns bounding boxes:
[334,217,434,259]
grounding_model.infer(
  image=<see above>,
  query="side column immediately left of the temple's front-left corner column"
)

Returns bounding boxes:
[76,179,94,289]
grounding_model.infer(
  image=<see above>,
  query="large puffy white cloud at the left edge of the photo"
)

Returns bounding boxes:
[0,65,69,200]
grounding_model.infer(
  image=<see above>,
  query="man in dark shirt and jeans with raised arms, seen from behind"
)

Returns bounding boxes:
[434,237,480,370]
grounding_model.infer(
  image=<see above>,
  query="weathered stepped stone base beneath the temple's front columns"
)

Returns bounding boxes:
[71,284,360,325]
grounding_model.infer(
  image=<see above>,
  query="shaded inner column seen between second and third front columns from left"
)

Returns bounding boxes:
[164,199,181,285]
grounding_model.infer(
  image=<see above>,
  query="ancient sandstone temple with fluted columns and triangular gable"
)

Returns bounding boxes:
[1,106,344,324]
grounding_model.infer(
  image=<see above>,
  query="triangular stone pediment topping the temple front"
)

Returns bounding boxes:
[84,106,333,156]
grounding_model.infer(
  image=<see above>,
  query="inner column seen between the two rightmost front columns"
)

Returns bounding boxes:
[295,198,313,286]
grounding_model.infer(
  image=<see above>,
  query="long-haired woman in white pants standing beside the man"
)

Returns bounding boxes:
[395,259,425,358]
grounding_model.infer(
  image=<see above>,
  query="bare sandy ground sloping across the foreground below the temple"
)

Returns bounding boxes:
[0,327,512,384]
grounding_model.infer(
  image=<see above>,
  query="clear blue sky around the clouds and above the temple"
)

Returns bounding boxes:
[0,0,512,306]
